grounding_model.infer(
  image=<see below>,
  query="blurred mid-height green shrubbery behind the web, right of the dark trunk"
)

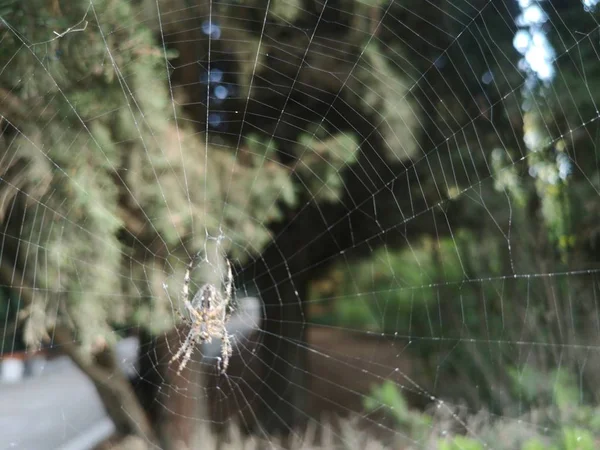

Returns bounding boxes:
[314,152,595,413]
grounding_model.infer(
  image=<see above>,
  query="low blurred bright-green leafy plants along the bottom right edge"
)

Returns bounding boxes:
[364,369,600,450]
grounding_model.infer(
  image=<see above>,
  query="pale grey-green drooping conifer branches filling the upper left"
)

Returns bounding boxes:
[0,0,296,354]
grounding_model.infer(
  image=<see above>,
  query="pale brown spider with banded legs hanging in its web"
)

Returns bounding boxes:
[169,256,233,375]
